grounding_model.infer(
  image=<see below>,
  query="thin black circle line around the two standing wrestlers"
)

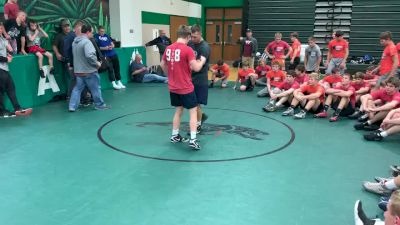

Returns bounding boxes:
[97,107,296,163]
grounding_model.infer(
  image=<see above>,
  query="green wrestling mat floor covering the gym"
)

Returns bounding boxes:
[0,84,400,225]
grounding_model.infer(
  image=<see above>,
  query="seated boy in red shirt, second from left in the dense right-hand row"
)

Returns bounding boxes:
[263,70,300,112]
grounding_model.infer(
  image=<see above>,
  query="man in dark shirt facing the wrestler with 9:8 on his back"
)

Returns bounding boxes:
[188,25,211,133]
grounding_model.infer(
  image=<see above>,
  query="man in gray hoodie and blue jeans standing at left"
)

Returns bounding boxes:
[69,25,109,112]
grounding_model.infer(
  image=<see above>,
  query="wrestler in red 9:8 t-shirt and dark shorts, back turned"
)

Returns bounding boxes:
[161,25,206,150]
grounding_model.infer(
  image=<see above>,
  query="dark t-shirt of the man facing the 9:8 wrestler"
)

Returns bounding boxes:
[188,40,211,85]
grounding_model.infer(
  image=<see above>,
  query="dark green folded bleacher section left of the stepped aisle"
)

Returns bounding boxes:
[248,0,315,52]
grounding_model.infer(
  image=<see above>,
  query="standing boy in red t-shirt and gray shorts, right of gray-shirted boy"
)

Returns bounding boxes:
[325,30,349,75]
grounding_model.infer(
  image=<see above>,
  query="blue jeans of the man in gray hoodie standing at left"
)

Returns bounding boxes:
[69,72,105,110]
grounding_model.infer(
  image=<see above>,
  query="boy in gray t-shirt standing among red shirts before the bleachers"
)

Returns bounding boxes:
[304,37,322,73]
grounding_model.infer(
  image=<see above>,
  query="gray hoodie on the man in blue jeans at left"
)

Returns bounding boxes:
[72,35,97,73]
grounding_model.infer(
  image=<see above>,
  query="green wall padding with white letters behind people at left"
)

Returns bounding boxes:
[6,47,146,109]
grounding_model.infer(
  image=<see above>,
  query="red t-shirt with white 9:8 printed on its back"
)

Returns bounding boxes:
[162,42,196,95]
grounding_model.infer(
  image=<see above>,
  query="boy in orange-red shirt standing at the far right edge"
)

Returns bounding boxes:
[373,31,399,86]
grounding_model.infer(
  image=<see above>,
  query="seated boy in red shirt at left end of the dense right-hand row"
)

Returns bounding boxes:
[257,61,285,97]
